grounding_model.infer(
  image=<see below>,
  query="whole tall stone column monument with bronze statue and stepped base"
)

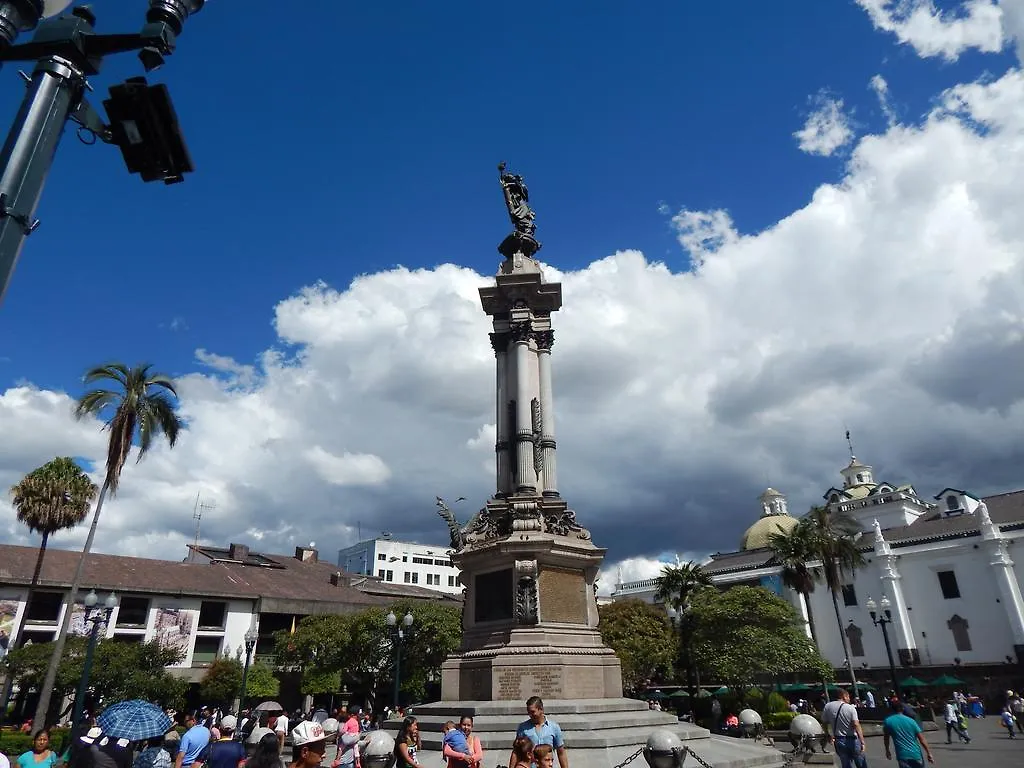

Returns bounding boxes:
[403,163,782,768]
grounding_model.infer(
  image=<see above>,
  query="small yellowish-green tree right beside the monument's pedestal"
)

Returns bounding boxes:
[598,600,676,692]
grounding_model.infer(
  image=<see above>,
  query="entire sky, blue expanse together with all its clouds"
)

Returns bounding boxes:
[0,0,1024,573]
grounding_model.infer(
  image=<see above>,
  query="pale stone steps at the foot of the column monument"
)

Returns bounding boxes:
[399,698,784,768]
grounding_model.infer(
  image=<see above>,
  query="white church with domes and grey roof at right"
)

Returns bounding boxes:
[613,458,1024,677]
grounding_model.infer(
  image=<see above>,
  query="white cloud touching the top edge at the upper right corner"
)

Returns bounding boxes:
[856,0,1003,61]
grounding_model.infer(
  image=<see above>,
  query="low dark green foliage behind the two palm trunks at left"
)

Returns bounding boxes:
[7,636,187,707]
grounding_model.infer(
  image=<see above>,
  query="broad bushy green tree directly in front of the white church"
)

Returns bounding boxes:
[690,587,831,688]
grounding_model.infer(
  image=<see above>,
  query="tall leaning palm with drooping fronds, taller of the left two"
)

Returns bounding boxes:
[35,362,182,725]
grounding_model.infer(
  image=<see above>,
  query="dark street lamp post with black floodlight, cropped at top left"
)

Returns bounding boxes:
[0,0,206,307]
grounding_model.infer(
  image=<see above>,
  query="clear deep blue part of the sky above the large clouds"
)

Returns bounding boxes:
[0,0,1009,388]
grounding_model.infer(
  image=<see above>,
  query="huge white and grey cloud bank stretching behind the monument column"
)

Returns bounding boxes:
[6,71,1024,569]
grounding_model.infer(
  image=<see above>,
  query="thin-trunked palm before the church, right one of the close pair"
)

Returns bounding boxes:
[801,507,865,696]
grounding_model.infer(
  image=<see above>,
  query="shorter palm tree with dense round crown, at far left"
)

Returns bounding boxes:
[0,457,99,722]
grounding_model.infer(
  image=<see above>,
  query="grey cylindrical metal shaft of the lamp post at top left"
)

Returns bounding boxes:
[0,51,85,301]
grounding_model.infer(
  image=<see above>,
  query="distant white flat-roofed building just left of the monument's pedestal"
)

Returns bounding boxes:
[338,537,462,595]
